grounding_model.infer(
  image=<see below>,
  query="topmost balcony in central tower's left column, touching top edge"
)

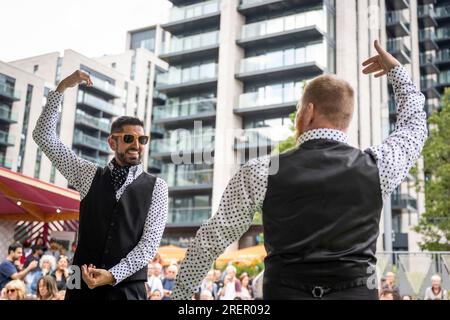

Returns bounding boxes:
[162,0,220,34]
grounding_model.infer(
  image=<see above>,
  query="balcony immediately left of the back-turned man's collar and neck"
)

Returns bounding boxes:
[234,127,292,153]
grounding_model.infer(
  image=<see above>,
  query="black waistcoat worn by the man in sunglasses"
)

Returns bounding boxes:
[74,167,156,282]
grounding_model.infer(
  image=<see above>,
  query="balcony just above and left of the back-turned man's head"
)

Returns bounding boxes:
[236,45,326,81]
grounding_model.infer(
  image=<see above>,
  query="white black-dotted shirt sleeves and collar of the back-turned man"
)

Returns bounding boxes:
[173,66,428,300]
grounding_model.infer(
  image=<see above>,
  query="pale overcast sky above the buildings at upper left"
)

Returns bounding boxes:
[0,0,171,62]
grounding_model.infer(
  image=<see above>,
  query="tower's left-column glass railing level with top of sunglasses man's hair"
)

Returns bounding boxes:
[153,99,217,120]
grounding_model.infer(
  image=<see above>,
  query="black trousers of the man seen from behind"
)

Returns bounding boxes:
[263,281,378,300]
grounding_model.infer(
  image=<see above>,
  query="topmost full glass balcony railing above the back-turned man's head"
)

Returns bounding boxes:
[241,10,326,40]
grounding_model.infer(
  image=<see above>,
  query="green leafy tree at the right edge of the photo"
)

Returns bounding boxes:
[415,89,450,251]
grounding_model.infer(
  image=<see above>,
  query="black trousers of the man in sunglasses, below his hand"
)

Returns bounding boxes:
[65,281,147,300]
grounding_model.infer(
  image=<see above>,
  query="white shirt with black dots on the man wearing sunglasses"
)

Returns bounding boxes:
[33,91,168,285]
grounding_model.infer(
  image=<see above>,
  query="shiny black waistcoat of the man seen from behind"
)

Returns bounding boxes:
[262,140,382,284]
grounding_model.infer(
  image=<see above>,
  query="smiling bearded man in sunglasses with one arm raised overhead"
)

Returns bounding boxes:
[33,71,168,300]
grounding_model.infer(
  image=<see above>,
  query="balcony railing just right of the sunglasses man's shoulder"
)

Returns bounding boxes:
[161,169,213,187]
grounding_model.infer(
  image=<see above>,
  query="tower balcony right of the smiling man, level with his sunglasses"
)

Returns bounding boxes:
[150,132,215,158]
